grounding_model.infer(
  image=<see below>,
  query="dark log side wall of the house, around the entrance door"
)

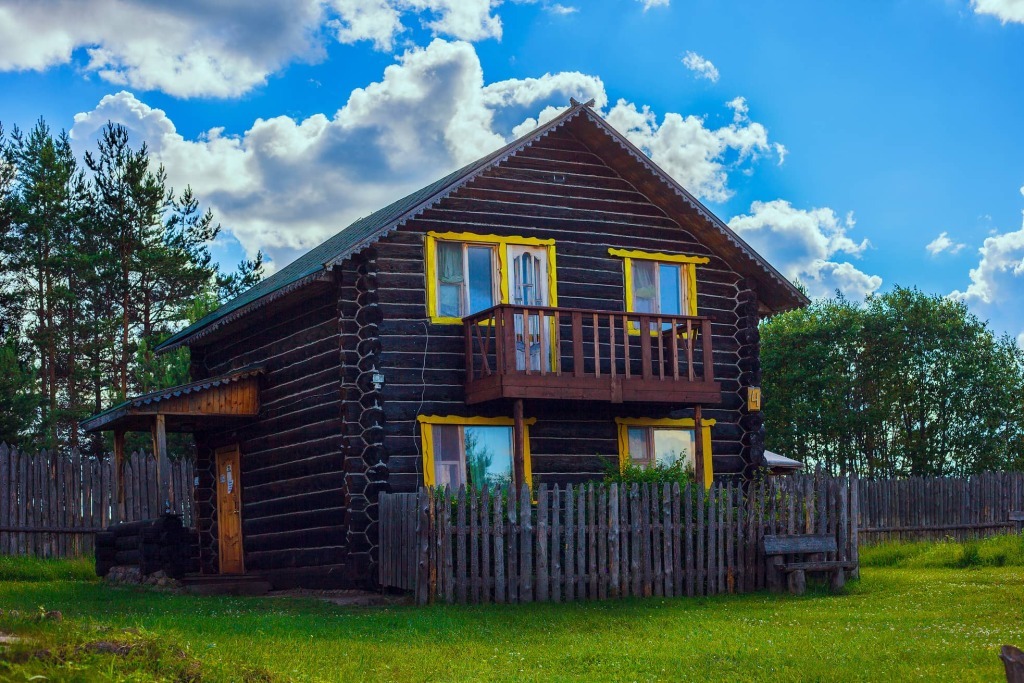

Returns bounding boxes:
[191,282,347,583]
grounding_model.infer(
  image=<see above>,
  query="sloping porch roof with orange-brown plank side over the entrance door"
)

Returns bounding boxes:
[81,366,265,432]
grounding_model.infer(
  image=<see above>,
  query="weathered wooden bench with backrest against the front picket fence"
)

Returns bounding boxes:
[763,535,857,595]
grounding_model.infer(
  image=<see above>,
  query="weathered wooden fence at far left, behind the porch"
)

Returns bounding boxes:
[0,443,195,557]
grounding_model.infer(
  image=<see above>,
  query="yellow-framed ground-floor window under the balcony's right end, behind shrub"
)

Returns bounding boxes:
[615,418,715,486]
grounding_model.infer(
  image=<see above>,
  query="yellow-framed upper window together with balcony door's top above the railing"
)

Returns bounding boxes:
[425,232,558,324]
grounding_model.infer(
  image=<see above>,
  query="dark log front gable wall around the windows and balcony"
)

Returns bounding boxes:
[376,128,760,492]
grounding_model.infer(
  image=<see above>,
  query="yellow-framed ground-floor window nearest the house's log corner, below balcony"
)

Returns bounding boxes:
[419,416,536,488]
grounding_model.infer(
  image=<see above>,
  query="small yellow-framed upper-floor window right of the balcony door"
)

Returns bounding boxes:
[608,249,710,333]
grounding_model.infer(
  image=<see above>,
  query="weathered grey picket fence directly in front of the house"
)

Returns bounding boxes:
[379,475,858,604]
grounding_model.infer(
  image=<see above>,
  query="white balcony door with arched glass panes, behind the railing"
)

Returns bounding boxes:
[508,245,555,372]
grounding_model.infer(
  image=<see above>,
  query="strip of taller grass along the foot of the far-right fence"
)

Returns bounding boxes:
[860,533,1024,569]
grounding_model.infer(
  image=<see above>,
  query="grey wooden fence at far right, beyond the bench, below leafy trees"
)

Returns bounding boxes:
[858,472,1024,543]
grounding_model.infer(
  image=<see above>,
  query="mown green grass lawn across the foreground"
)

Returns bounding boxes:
[0,539,1024,681]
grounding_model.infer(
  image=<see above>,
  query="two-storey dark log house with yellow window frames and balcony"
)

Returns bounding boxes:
[85,100,807,586]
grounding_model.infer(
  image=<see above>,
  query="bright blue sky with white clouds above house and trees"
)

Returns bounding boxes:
[0,0,1024,344]
